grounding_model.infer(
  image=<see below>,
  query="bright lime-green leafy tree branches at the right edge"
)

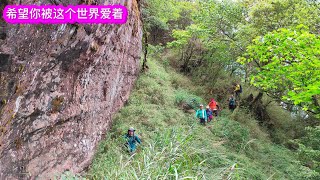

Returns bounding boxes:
[238,25,320,115]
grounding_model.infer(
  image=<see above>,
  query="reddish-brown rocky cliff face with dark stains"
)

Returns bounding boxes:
[0,0,142,179]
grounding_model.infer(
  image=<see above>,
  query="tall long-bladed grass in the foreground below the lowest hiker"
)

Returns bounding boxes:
[88,128,209,179]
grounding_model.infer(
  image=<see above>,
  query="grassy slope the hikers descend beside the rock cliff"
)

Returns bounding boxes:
[87,58,311,179]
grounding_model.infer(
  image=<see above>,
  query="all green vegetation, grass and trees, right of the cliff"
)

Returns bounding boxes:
[86,0,320,179]
